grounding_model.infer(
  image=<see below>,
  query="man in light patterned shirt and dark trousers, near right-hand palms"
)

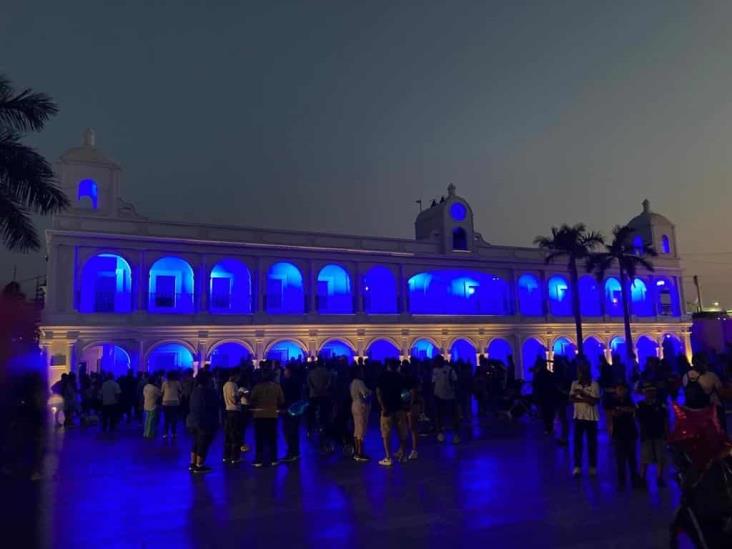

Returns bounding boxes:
[569,359,600,477]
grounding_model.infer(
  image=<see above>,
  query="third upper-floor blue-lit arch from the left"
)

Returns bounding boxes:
[208,259,252,314]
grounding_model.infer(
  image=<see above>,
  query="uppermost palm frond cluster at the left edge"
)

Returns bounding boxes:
[0,75,58,132]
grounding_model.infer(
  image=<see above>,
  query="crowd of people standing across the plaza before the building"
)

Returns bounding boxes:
[53,346,732,487]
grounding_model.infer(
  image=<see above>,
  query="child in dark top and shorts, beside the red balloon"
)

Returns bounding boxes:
[638,383,668,486]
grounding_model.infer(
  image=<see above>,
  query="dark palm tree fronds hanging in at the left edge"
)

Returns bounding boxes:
[0,75,68,251]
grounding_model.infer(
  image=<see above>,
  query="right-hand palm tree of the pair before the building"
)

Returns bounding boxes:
[587,225,658,364]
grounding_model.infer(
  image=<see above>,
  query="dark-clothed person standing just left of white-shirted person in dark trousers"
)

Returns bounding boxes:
[186,370,219,474]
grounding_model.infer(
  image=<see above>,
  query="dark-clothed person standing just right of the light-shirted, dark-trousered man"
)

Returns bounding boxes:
[611,383,640,488]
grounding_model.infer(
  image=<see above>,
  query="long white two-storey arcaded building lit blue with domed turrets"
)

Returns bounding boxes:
[41,130,689,381]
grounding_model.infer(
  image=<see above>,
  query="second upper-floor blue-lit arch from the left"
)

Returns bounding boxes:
[148,256,194,313]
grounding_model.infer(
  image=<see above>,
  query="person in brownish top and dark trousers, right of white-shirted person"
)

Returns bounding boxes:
[249,368,285,467]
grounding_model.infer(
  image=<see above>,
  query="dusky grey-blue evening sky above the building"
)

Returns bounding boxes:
[0,0,732,306]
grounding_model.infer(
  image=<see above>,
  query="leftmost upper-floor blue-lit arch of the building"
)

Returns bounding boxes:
[78,254,132,313]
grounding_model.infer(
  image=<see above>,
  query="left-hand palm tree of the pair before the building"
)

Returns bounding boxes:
[534,223,604,355]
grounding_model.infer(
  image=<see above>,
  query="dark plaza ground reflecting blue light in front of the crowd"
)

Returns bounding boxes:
[40,411,678,549]
